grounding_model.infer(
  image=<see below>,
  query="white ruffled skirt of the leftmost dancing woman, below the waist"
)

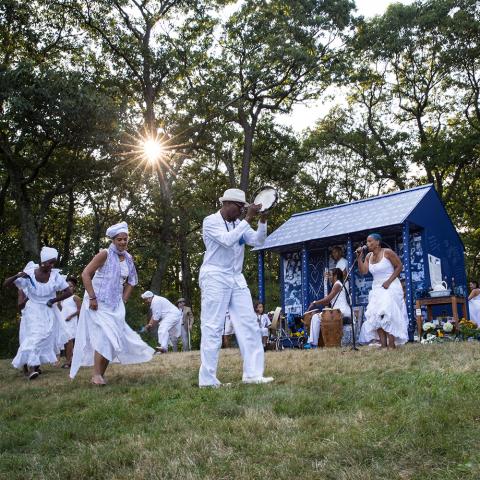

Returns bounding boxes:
[12,300,61,369]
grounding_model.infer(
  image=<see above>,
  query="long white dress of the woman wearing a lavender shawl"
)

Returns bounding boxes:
[70,261,155,378]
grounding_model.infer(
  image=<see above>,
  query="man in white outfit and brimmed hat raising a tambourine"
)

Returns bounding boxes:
[199,188,273,388]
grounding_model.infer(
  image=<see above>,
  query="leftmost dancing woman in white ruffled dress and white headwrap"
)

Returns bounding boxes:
[4,247,72,380]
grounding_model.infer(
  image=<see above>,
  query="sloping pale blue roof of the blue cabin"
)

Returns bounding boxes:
[261,185,433,250]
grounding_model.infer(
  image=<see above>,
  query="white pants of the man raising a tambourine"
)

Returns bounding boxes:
[198,274,265,387]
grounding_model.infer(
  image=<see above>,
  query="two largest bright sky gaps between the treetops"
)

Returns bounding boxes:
[277,0,414,132]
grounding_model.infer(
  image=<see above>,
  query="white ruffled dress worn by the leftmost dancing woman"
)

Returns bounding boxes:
[12,262,68,368]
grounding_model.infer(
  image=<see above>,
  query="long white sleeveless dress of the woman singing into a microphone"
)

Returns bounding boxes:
[359,254,408,345]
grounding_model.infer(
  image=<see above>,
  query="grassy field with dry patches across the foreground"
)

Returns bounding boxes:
[0,343,480,480]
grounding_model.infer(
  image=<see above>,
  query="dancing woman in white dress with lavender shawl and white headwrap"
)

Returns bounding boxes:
[70,222,154,385]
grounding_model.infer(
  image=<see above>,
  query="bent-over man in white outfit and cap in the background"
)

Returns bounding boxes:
[142,290,182,353]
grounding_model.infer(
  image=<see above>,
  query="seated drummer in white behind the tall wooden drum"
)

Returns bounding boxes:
[308,268,350,348]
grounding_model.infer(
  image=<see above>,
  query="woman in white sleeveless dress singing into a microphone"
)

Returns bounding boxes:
[355,233,408,348]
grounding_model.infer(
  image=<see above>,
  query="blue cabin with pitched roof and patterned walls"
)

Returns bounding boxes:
[256,185,467,340]
